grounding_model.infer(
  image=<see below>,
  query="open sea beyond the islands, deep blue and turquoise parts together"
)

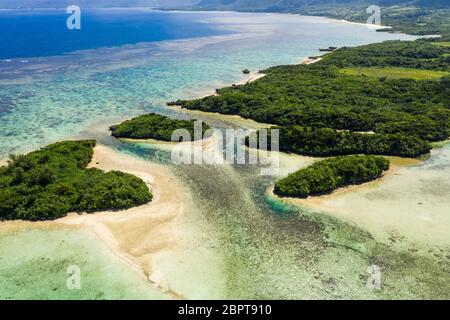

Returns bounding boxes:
[0,9,413,158]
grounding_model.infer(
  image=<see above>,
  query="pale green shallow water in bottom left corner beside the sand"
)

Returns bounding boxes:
[0,228,167,300]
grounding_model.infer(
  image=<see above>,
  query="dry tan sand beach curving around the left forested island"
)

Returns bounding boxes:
[0,145,221,299]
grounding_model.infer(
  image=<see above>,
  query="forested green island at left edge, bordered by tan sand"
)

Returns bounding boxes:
[0,140,152,221]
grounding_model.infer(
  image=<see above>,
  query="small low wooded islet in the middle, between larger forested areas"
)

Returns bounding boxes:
[110,113,210,142]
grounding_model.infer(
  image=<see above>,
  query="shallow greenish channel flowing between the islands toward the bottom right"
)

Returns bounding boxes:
[116,143,450,299]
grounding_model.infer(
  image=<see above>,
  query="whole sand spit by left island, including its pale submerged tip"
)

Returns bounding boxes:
[0,145,224,299]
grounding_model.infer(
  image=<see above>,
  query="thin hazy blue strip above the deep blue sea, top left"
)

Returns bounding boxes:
[0,0,199,9]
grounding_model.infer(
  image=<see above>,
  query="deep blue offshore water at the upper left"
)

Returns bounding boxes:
[0,9,226,59]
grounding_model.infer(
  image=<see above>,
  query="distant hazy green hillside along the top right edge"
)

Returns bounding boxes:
[185,0,450,37]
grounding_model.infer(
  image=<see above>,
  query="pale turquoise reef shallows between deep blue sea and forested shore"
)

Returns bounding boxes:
[0,13,416,158]
